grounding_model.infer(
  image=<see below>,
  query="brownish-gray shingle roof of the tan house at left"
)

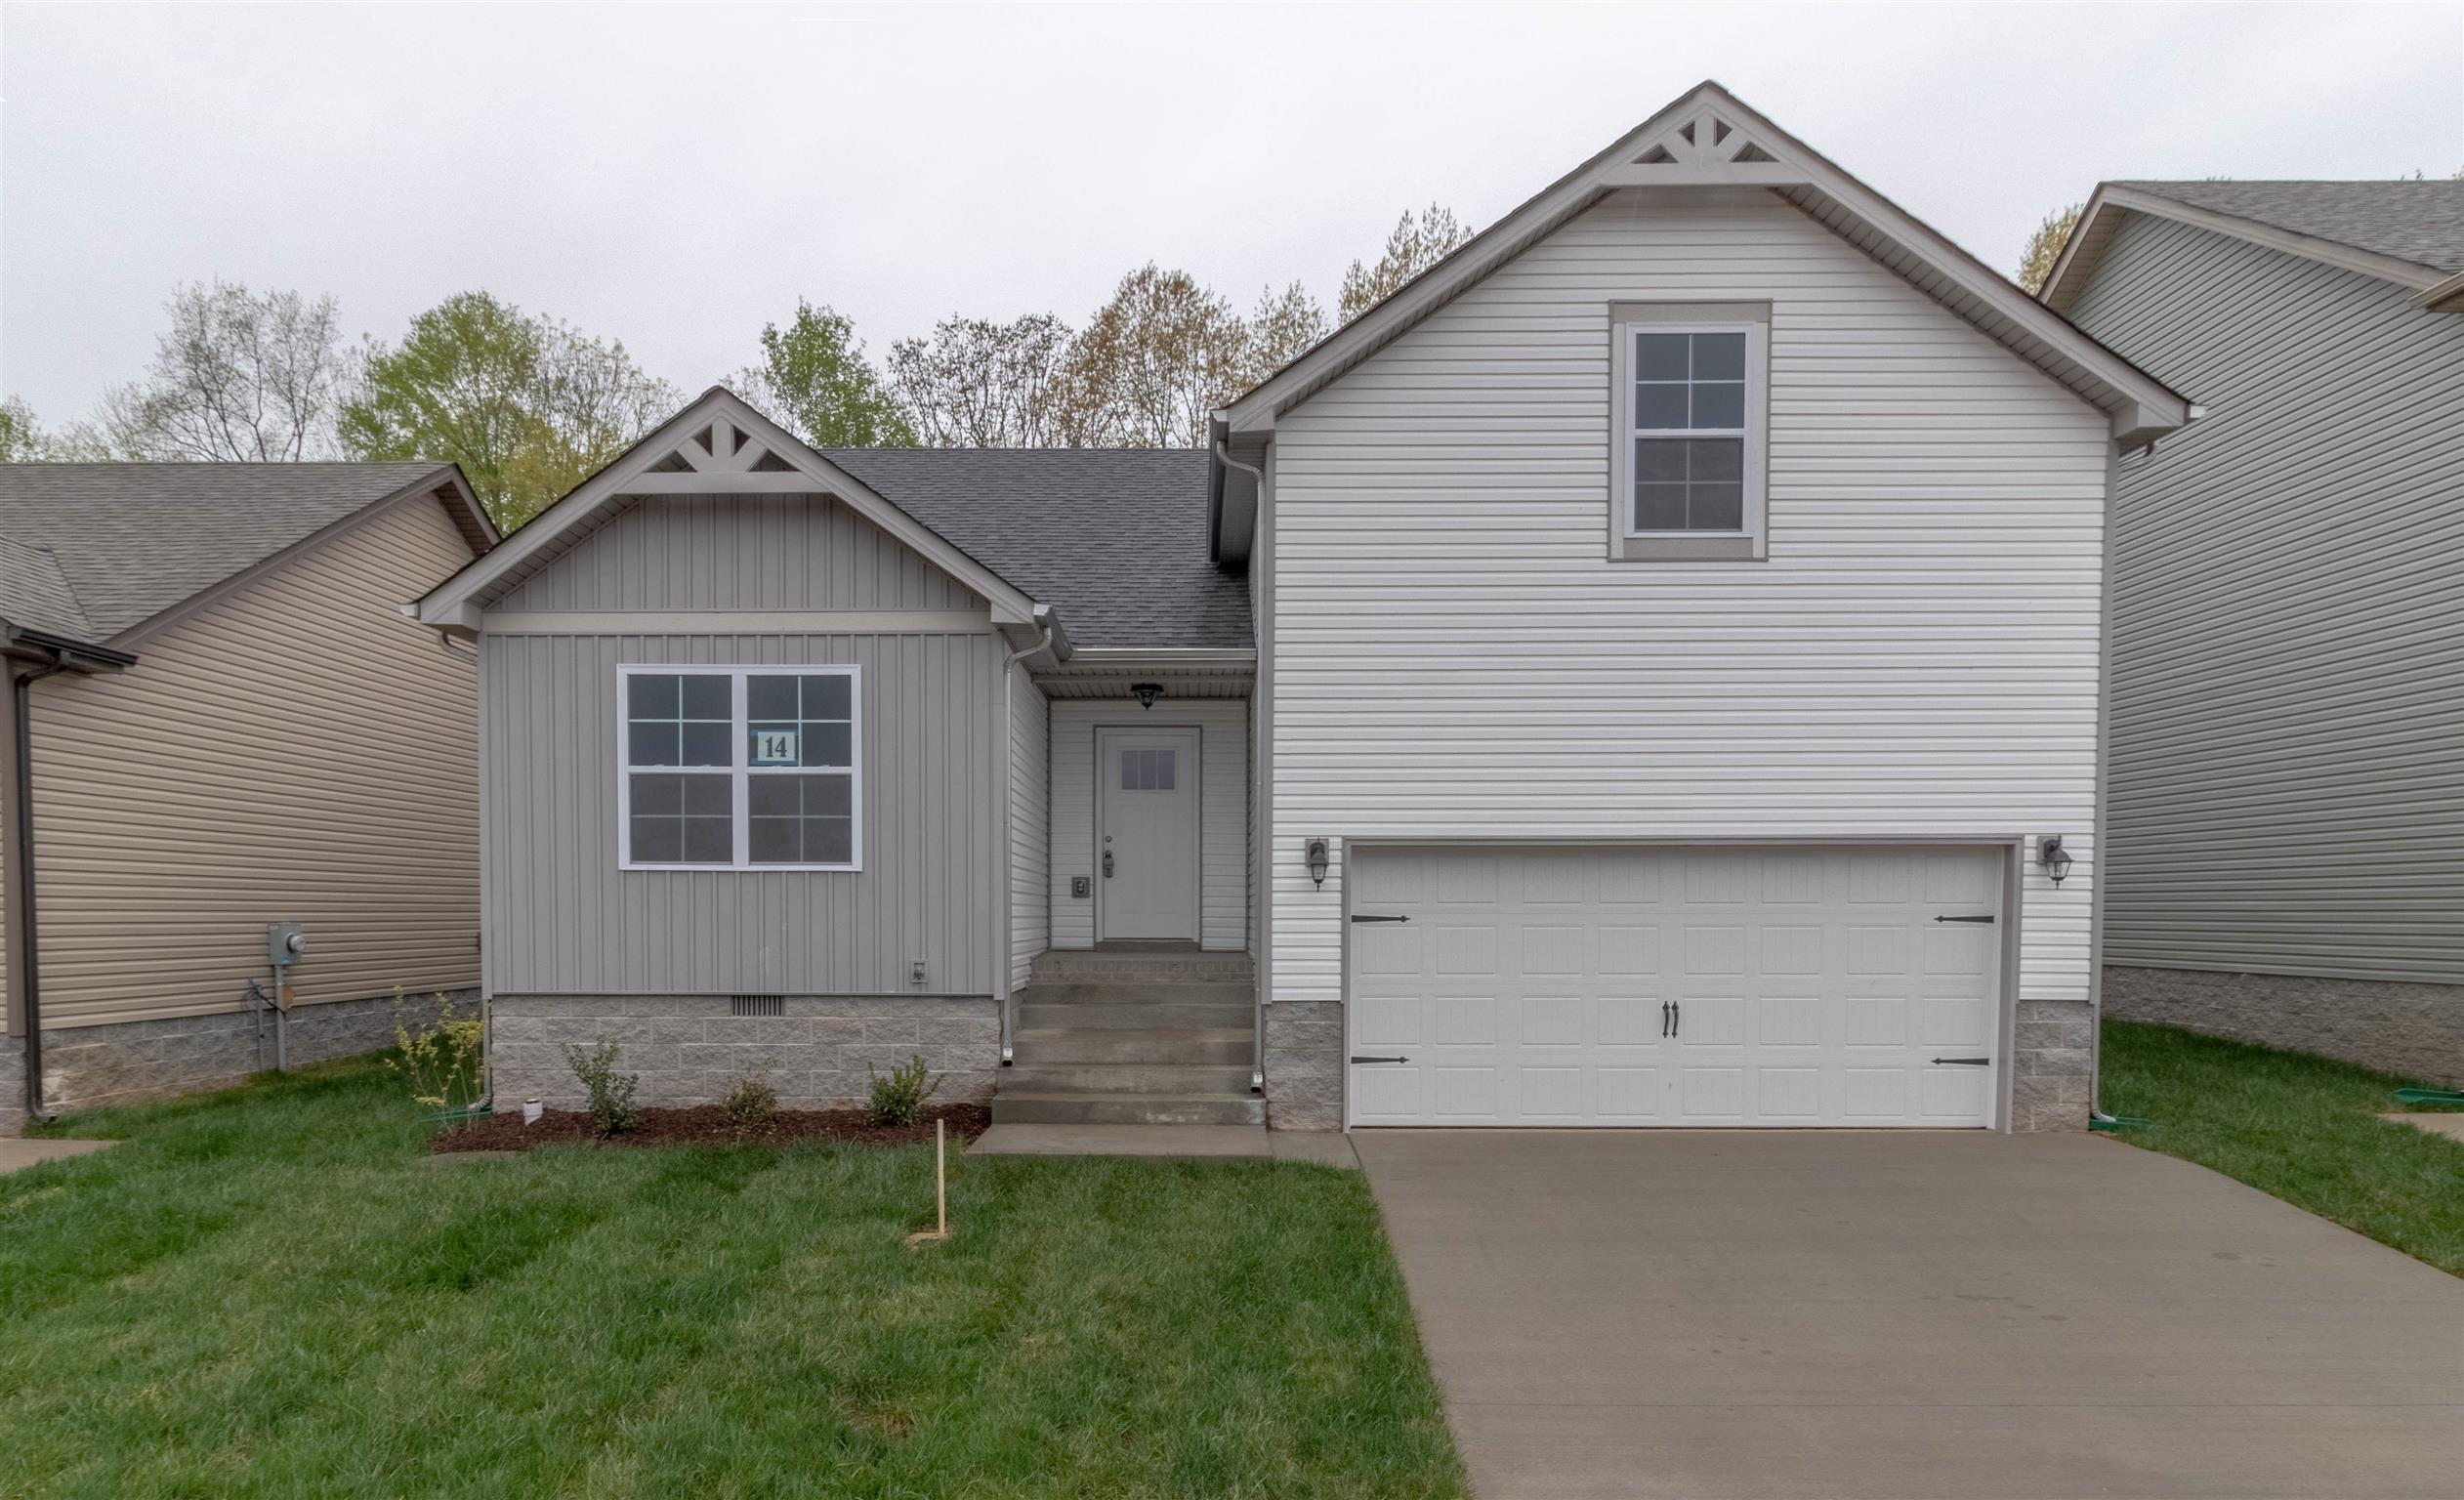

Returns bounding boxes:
[0,463,460,643]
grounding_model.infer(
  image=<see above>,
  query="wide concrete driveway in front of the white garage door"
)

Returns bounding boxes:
[1353,1131,2464,1500]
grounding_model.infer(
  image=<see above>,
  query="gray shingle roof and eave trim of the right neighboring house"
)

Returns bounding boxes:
[2040,180,2464,311]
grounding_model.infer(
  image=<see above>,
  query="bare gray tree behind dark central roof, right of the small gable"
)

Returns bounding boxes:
[890,312,1072,448]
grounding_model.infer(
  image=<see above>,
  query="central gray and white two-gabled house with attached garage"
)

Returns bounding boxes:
[419,84,2193,1131]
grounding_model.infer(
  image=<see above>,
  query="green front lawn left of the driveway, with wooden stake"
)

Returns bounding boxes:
[0,1062,1464,1500]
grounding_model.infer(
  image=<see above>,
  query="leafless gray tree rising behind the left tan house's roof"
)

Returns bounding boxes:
[101,281,345,463]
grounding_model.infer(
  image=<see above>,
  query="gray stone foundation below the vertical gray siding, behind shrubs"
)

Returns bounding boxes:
[490,995,1000,1108]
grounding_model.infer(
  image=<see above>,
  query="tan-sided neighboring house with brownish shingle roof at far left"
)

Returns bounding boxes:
[0,463,495,1131]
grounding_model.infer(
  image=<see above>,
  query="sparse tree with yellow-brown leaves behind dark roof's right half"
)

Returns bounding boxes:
[1065,261,1249,448]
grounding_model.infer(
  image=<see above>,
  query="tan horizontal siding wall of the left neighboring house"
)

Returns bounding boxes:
[14,495,478,1029]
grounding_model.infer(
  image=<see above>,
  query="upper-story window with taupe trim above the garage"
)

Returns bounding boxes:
[1609,303,1770,562]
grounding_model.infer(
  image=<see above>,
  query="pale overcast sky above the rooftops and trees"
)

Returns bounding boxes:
[0,3,2464,424]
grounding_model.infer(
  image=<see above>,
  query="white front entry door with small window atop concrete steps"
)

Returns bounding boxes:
[1094,729,1197,943]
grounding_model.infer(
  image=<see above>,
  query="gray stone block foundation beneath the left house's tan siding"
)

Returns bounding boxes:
[0,990,463,1136]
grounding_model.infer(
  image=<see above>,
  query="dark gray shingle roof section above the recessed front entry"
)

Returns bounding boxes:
[825,448,1252,646]
